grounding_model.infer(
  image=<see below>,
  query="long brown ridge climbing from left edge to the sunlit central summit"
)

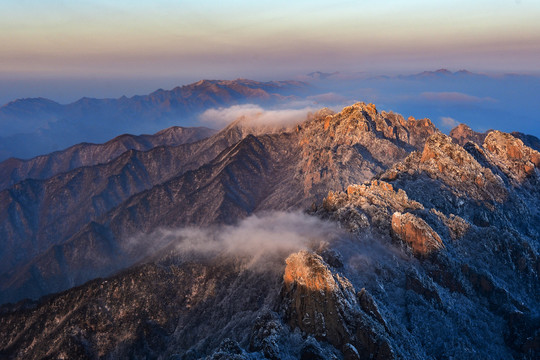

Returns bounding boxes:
[0,103,436,301]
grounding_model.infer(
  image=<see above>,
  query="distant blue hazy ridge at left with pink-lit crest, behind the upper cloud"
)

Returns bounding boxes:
[0,79,307,161]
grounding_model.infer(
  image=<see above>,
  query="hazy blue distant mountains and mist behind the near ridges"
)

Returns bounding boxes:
[4,69,540,161]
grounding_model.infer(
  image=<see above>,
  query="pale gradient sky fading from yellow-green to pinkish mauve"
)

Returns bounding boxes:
[0,0,540,79]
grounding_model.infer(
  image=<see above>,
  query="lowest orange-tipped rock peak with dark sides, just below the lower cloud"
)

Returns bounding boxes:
[282,251,394,359]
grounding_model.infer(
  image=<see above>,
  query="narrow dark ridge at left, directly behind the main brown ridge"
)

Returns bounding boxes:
[0,126,216,190]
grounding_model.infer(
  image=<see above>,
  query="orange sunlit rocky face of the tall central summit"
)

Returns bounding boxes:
[299,103,436,192]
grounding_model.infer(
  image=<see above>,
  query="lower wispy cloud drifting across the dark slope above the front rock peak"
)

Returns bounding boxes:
[130,212,341,268]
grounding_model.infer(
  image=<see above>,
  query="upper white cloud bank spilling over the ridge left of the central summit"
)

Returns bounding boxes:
[200,104,318,127]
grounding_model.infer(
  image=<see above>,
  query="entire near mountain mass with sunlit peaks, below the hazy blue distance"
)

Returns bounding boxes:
[0,103,540,359]
